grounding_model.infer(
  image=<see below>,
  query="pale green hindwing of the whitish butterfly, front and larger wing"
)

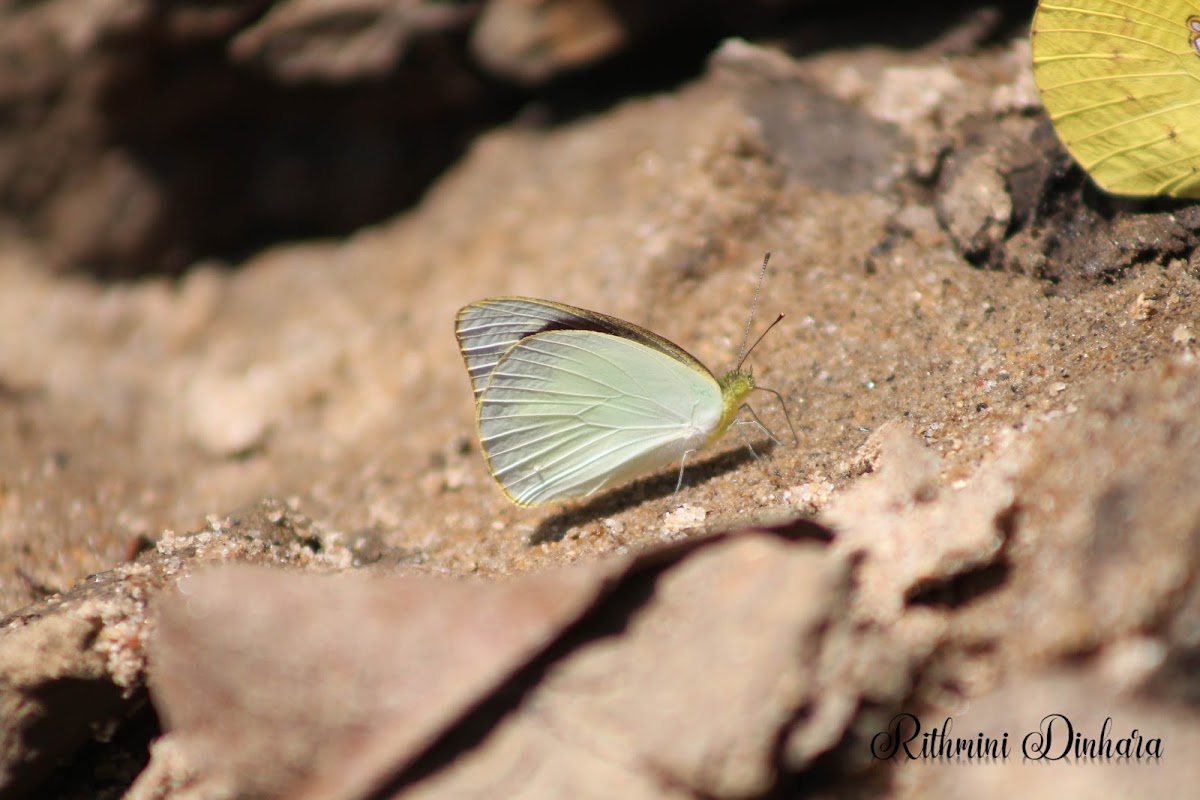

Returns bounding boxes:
[468,330,722,505]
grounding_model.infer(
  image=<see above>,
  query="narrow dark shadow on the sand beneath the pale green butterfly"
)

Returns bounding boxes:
[529,439,775,546]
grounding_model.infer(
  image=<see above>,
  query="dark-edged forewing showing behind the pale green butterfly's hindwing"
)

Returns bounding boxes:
[455,297,708,402]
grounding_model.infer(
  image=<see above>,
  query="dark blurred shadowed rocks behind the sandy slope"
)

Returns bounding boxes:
[0,0,1033,277]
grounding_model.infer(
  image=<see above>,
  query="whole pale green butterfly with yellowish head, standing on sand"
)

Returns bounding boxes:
[456,297,754,505]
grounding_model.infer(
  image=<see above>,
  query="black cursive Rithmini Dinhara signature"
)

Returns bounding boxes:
[871,714,1163,763]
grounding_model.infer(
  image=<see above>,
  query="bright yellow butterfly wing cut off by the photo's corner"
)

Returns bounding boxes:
[1032,0,1200,197]
